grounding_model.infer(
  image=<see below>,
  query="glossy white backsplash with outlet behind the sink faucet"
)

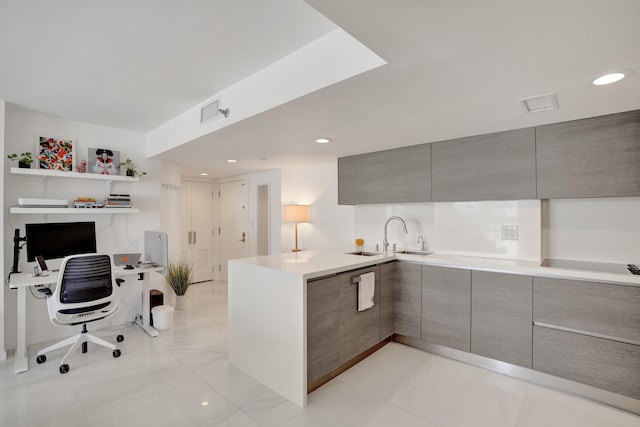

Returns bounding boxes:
[354,200,541,261]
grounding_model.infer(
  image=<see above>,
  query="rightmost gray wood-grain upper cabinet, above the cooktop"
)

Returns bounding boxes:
[536,111,640,199]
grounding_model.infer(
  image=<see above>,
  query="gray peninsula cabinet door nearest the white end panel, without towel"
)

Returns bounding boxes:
[307,276,344,386]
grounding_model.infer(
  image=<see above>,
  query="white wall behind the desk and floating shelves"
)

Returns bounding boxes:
[3,104,161,348]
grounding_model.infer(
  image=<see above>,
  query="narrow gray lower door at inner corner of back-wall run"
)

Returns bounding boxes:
[394,262,422,339]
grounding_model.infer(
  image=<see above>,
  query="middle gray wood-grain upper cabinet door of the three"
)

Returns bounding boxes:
[431,128,536,202]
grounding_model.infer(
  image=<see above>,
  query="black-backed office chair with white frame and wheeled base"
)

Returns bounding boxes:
[36,254,124,374]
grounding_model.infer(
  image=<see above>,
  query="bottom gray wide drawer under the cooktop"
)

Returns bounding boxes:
[533,326,640,399]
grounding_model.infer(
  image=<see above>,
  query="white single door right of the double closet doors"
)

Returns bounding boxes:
[218,179,248,280]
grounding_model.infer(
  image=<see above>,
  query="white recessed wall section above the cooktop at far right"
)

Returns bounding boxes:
[543,197,640,264]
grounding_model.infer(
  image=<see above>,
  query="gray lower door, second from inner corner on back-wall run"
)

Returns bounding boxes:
[421,266,471,351]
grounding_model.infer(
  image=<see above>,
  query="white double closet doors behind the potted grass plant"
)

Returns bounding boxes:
[180,181,213,282]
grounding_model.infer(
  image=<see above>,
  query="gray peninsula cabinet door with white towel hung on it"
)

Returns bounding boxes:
[339,266,380,364]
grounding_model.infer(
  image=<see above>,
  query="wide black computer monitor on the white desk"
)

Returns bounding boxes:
[25,222,97,262]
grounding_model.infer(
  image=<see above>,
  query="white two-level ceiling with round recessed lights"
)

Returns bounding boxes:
[0,0,640,177]
